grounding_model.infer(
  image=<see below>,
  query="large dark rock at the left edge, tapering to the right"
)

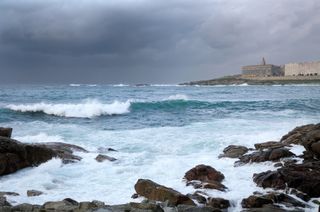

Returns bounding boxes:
[0,137,57,176]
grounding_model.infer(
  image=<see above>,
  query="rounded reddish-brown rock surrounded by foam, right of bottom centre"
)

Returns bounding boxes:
[184,164,224,182]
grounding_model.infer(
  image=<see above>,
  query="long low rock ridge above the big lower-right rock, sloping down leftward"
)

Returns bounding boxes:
[235,148,295,165]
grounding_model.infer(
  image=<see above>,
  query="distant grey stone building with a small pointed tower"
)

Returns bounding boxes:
[241,58,284,77]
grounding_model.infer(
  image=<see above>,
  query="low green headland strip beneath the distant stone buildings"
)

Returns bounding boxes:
[181,75,320,85]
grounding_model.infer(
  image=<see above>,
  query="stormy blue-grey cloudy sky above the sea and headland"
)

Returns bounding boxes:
[0,0,320,83]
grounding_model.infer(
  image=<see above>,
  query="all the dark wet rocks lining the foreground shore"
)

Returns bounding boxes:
[0,123,320,212]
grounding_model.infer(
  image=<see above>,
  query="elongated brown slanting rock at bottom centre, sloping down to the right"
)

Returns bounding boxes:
[134,179,194,205]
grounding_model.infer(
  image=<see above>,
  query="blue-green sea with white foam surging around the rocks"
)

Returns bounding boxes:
[0,84,320,211]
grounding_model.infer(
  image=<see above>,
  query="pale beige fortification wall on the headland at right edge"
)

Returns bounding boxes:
[284,62,320,76]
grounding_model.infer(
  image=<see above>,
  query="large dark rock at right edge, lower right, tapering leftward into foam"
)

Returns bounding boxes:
[253,161,320,197]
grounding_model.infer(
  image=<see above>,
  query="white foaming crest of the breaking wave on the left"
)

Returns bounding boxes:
[6,100,130,118]
